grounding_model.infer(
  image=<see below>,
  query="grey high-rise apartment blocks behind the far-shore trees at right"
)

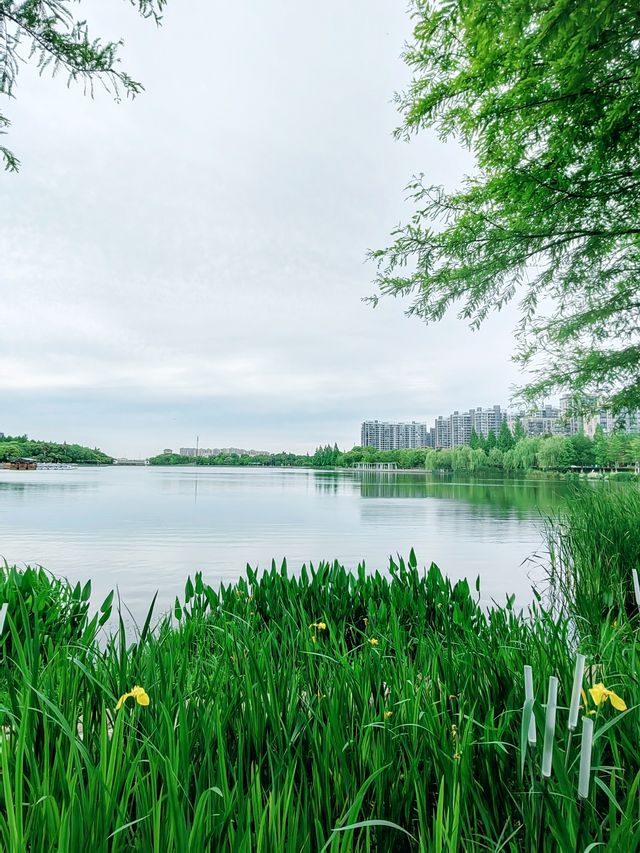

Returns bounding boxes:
[360,394,640,450]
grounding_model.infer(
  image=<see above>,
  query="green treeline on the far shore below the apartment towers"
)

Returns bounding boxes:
[149,423,640,471]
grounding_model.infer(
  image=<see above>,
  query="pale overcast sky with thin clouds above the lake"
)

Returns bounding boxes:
[0,0,518,456]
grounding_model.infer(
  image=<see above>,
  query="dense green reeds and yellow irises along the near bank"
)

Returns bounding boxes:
[0,482,640,853]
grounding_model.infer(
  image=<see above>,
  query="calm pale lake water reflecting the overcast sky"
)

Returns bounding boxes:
[0,467,568,617]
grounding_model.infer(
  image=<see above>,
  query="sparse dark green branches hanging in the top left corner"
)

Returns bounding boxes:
[0,0,166,171]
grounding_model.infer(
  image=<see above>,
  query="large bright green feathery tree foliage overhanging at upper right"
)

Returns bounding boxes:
[373,0,640,411]
